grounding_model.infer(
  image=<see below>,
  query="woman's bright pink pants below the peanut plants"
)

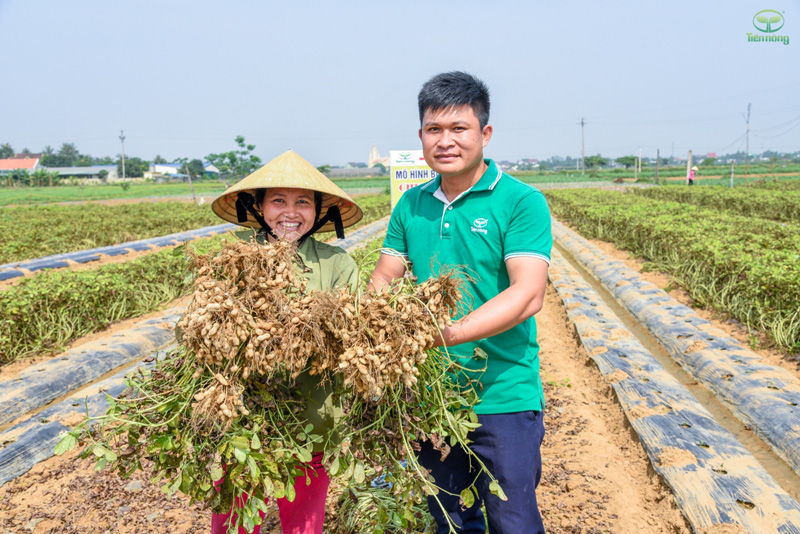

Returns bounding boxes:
[211,454,331,534]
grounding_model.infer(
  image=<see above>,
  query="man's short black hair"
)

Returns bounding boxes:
[417,71,489,130]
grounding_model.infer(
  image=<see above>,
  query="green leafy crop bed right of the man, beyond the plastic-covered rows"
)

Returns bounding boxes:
[547,190,800,352]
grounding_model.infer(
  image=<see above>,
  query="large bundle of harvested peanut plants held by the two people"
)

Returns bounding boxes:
[56,241,504,528]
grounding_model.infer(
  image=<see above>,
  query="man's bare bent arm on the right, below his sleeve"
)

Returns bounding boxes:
[432,256,548,346]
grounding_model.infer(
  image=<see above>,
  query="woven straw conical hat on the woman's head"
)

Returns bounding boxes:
[211,150,364,232]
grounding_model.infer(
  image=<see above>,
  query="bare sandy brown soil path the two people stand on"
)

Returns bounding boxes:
[0,288,690,534]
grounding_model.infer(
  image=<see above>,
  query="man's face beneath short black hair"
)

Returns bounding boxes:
[419,105,492,177]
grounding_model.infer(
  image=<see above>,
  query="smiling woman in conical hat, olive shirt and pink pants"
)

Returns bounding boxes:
[211,150,363,534]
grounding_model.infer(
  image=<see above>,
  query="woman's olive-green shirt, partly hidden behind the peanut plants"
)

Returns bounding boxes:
[236,230,358,452]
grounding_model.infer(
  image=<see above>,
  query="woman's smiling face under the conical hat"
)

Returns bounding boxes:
[261,187,316,241]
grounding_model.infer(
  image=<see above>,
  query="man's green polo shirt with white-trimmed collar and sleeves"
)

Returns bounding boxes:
[382,159,553,414]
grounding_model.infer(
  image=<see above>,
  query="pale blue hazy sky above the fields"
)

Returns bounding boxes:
[0,0,800,165]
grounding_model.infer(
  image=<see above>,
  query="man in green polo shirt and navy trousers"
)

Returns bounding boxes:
[372,72,552,534]
